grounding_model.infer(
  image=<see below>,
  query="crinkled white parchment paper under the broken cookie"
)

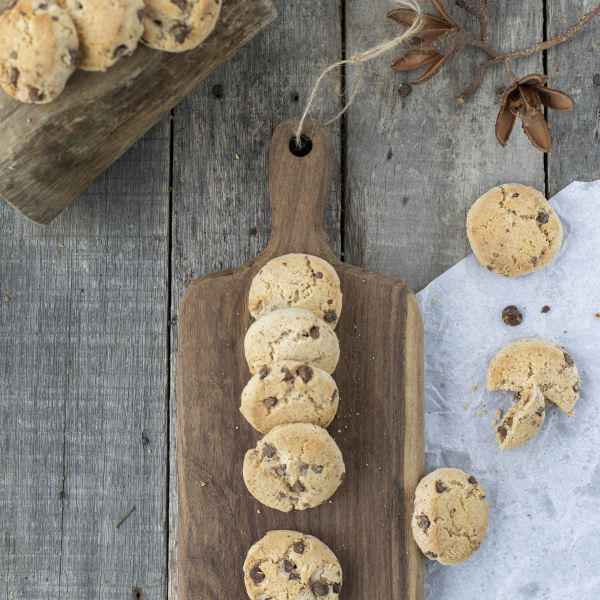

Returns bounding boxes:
[418,181,600,600]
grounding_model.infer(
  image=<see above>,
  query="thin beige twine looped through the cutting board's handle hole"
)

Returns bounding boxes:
[295,0,423,147]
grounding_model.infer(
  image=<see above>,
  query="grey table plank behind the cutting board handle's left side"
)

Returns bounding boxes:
[169,2,341,600]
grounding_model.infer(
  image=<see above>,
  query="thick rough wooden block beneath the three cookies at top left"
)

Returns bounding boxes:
[0,0,275,224]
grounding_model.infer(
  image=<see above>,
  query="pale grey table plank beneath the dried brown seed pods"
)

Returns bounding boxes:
[345,0,544,290]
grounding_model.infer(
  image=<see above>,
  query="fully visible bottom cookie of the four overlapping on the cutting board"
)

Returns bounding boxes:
[243,423,346,512]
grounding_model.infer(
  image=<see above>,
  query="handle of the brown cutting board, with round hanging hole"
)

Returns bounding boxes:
[269,119,335,260]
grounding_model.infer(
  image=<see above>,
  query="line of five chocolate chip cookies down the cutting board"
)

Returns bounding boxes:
[240,254,345,600]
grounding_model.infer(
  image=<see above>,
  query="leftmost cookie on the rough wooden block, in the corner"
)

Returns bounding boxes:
[0,0,81,104]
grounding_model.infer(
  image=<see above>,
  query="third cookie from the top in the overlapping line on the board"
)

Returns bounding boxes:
[240,360,338,433]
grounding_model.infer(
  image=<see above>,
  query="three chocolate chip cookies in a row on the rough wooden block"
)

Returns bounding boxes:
[0,0,221,104]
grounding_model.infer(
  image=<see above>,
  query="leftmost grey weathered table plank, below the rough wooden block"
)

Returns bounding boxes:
[0,120,169,600]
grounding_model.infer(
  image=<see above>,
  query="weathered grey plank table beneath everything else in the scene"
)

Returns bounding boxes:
[0,0,600,600]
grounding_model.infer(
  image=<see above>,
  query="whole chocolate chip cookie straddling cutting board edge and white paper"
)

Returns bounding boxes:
[412,469,488,565]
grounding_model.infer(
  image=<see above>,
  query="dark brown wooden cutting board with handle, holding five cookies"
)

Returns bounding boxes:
[178,121,424,600]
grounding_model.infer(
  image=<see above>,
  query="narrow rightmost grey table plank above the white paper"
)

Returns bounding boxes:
[547,0,600,195]
